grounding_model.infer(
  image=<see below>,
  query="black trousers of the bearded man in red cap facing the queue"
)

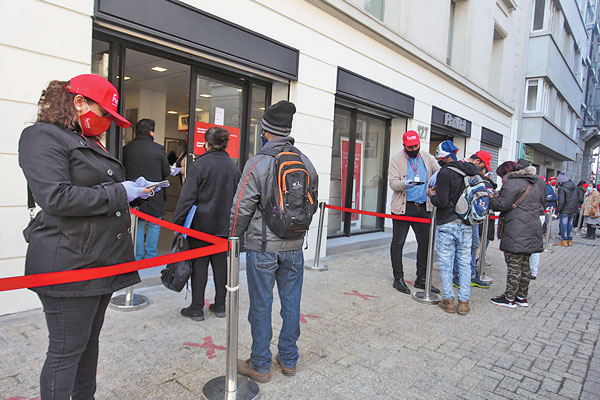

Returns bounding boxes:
[390,202,431,281]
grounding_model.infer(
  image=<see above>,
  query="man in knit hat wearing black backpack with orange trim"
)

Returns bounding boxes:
[231,100,319,383]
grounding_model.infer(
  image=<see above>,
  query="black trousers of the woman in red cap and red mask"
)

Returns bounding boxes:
[38,294,112,400]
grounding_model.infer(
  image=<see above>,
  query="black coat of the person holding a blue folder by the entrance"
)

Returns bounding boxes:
[173,149,240,248]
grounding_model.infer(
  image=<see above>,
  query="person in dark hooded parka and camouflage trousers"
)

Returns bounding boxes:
[490,161,546,308]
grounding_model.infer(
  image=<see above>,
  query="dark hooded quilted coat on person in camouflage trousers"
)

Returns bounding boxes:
[490,166,546,254]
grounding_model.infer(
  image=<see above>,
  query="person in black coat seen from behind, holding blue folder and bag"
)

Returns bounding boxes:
[173,127,240,321]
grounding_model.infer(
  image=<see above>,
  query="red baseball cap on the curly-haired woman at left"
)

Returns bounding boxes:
[67,74,131,128]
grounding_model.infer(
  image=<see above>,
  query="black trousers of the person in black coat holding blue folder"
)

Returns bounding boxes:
[188,238,227,310]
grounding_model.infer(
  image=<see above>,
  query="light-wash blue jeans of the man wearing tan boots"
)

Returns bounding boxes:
[435,222,472,301]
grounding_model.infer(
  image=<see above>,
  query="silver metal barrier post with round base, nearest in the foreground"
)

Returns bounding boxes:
[202,237,259,400]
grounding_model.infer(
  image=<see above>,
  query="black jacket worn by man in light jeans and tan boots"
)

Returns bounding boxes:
[431,161,479,225]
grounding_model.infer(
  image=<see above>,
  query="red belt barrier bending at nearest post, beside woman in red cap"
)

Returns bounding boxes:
[0,209,228,292]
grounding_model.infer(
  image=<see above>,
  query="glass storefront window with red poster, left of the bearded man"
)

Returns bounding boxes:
[327,107,389,236]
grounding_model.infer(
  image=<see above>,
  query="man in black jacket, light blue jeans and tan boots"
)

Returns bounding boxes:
[427,147,487,315]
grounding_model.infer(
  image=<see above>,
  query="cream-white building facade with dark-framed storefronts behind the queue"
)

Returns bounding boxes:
[0,0,527,315]
